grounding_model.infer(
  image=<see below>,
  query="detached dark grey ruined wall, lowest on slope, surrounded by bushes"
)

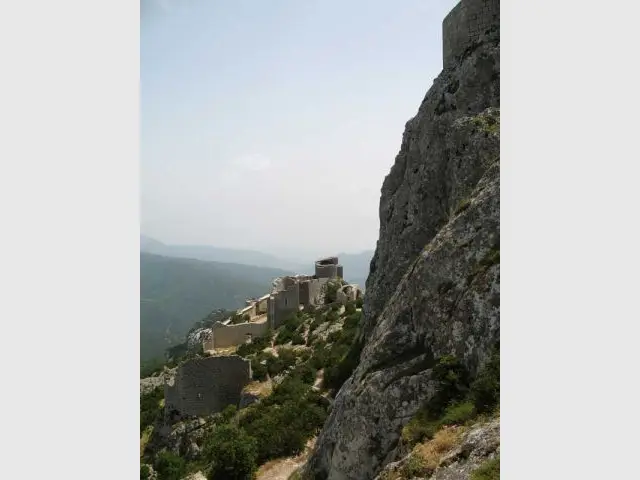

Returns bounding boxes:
[164,355,251,416]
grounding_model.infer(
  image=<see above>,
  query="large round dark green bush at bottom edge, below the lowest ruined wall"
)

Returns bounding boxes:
[203,424,258,480]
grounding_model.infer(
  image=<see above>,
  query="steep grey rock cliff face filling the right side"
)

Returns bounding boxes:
[305,9,500,480]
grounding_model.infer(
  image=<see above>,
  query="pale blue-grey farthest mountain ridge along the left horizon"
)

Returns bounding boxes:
[140,235,302,273]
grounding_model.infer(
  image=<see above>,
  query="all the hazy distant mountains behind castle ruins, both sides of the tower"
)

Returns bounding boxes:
[140,235,373,361]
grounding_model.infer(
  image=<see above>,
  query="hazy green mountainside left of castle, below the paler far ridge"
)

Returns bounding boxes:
[140,251,293,360]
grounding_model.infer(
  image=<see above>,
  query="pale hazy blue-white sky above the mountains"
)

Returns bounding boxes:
[140,0,457,255]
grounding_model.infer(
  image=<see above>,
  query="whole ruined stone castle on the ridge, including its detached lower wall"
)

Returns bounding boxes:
[164,257,362,418]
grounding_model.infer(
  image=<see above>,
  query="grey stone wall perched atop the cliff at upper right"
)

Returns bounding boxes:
[442,0,500,68]
